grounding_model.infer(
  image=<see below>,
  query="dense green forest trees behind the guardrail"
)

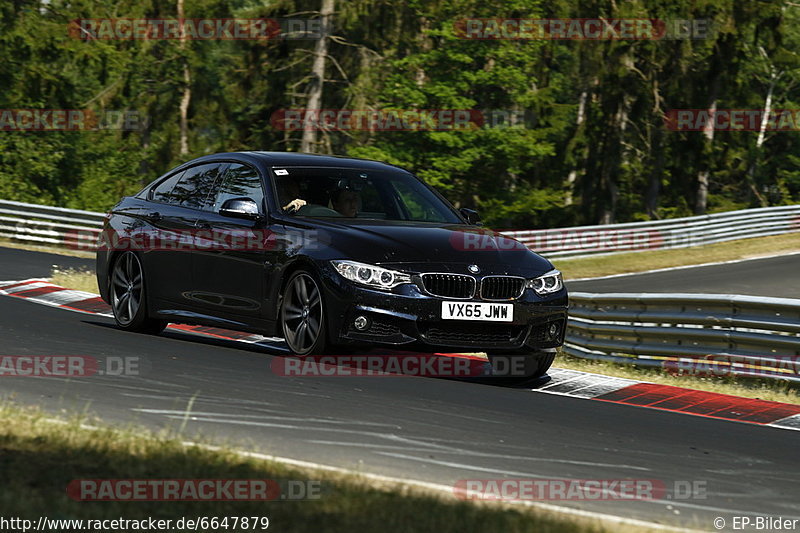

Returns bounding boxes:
[0,0,800,228]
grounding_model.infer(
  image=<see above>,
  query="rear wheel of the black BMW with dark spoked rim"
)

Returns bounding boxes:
[109,252,167,335]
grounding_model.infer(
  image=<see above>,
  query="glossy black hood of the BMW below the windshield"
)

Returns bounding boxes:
[296,221,553,277]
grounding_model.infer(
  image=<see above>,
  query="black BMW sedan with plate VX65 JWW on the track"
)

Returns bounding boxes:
[97,152,567,376]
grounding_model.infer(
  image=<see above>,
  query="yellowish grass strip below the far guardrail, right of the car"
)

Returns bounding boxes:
[553,233,800,280]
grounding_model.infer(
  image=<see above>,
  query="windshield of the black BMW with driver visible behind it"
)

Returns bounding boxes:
[273,167,462,224]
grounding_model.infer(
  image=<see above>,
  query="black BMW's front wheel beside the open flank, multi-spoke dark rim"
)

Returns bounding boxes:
[280,270,328,355]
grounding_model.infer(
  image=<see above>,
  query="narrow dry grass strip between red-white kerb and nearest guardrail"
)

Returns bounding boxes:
[553,353,800,405]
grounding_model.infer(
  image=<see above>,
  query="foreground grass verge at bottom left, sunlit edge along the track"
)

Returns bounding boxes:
[0,402,620,533]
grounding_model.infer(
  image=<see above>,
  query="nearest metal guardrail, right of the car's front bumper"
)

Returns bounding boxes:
[564,292,800,381]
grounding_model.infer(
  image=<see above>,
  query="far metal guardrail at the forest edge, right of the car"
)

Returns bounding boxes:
[503,205,800,258]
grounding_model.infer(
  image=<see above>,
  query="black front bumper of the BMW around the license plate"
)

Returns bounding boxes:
[325,273,568,351]
